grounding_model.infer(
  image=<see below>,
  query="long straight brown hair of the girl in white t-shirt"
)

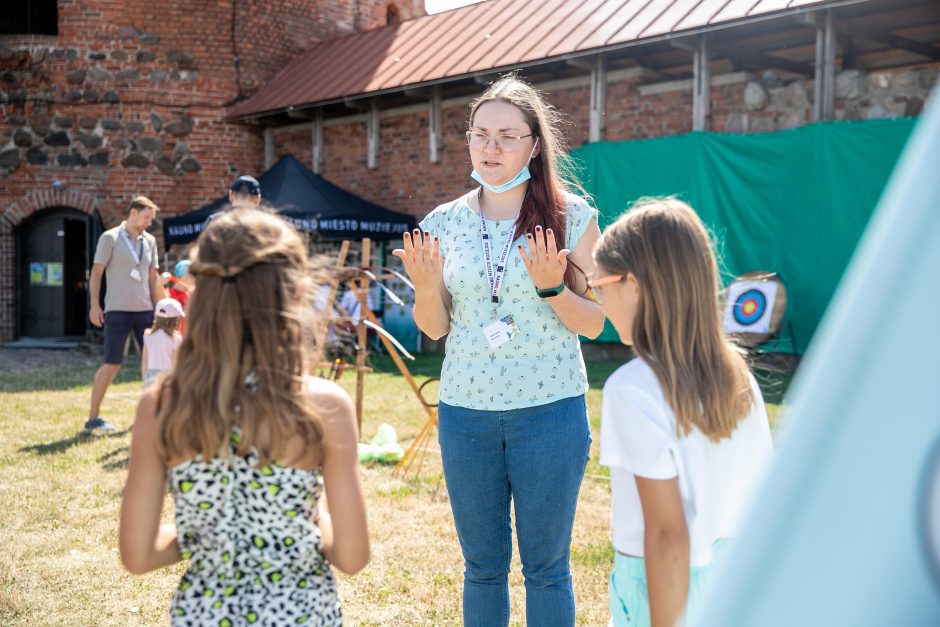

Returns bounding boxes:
[594,198,754,442]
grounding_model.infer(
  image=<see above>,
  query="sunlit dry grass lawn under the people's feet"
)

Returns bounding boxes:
[0,355,786,626]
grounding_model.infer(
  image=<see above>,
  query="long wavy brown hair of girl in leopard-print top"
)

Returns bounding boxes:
[157,209,323,463]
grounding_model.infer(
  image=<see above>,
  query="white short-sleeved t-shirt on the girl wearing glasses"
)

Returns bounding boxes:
[600,358,773,566]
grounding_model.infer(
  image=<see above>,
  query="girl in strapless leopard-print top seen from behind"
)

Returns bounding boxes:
[120,209,369,626]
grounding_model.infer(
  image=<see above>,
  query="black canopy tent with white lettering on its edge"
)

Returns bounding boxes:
[163,155,416,248]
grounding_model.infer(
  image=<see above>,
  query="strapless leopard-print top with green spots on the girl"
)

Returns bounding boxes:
[167,432,342,627]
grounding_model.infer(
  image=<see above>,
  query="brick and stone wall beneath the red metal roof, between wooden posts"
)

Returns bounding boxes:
[276,66,938,226]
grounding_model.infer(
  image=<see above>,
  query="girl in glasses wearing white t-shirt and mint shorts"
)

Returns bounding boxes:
[590,198,772,627]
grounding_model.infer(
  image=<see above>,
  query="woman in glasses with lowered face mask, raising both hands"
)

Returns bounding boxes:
[395,75,604,627]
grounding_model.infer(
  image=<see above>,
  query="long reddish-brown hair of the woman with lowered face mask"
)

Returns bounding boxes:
[468,73,587,289]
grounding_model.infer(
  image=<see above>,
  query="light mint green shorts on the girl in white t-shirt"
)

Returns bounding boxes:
[607,540,729,627]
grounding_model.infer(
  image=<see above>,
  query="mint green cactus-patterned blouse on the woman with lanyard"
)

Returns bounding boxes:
[420,194,597,411]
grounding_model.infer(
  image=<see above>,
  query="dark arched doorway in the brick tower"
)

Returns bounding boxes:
[17,207,100,338]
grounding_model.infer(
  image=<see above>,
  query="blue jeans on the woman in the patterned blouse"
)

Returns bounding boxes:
[438,395,591,627]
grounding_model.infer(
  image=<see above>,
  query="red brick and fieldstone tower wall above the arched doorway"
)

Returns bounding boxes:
[0,0,423,342]
